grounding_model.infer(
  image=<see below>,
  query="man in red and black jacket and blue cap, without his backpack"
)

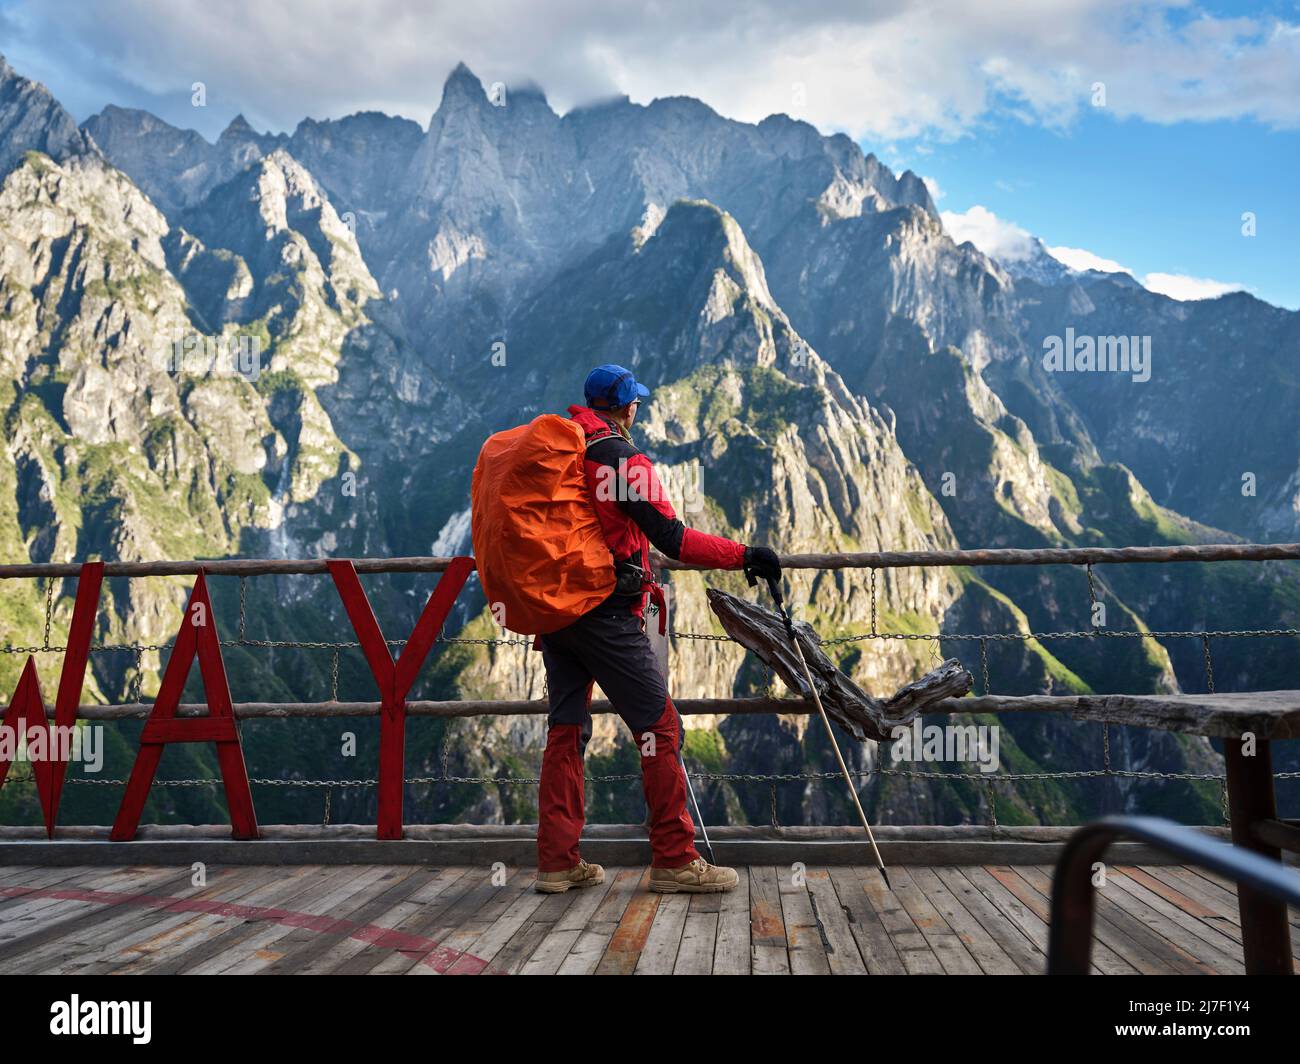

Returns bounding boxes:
[537,366,781,894]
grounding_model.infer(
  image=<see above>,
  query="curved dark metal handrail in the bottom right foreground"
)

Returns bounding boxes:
[1048,817,1300,976]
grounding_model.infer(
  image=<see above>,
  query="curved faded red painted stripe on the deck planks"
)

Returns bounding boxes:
[0,886,506,976]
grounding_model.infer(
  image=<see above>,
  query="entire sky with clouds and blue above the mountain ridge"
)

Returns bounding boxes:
[0,0,1300,308]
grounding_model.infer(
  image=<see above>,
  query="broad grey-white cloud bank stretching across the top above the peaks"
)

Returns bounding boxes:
[5,0,1300,140]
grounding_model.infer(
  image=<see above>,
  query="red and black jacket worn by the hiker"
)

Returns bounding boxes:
[568,406,745,613]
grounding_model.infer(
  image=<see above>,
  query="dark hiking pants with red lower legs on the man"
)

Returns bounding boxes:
[537,611,699,871]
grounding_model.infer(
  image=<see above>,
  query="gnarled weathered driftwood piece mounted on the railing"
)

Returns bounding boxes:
[707,588,972,743]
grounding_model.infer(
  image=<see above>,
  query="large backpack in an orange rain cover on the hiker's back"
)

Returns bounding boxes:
[469,414,615,635]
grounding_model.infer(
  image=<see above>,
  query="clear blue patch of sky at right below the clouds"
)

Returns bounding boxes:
[899,106,1300,310]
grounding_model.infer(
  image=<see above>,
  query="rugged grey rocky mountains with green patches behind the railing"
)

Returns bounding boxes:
[0,57,1300,823]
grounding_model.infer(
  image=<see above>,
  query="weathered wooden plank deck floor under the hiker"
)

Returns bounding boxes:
[0,865,1300,976]
